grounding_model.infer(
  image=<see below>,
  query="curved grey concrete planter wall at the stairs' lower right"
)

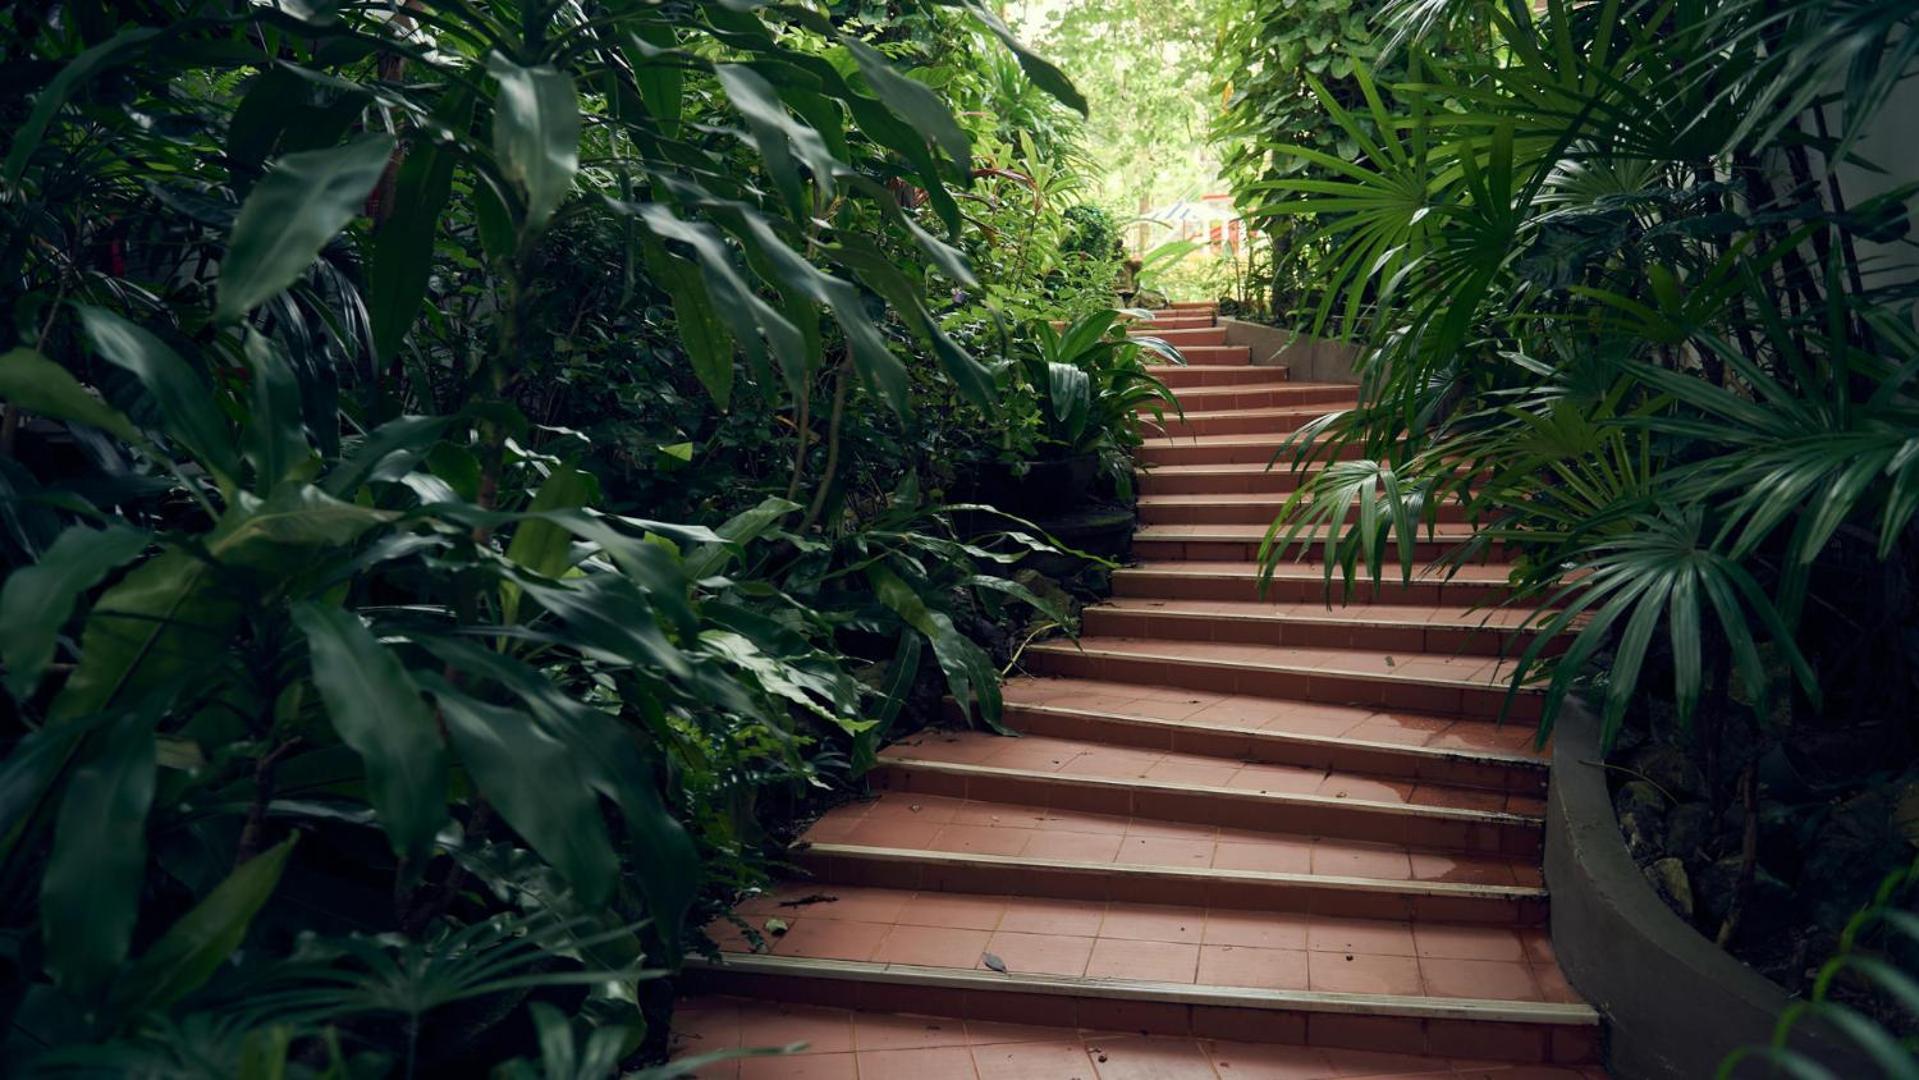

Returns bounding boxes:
[1547,702,1879,1080]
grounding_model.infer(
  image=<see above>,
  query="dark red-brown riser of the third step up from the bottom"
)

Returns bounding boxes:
[867,758,1541,857]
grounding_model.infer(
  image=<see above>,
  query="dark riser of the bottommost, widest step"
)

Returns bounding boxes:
[681,965,1599,1065]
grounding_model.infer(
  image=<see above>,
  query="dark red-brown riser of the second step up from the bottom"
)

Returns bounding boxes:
[798,852,1547,927]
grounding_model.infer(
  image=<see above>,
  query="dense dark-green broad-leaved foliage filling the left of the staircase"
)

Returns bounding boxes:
[0,0,1136,1076]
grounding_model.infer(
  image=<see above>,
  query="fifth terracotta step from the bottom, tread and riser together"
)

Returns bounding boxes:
[1023,637,1541,721]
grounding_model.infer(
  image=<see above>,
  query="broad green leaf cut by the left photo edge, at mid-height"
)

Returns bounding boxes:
[0,524,152,698]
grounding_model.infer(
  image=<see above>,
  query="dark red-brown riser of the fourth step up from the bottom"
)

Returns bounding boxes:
[1006,704,1547,796]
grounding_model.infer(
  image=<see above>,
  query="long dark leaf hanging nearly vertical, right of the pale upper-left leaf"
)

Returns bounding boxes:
[367,90,474,361]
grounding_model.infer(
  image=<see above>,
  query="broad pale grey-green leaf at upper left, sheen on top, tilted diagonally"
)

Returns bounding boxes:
[215,132,393,322]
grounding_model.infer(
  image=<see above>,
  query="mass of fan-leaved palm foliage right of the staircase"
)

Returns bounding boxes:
[1249,0,1919,973]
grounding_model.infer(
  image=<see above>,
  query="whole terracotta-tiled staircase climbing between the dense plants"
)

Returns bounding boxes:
[675,305,1602,1080]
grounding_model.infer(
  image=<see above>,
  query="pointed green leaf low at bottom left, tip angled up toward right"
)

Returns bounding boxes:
[113,833,299,1015]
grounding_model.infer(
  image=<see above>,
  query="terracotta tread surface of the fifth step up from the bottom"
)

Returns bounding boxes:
[1029,637,1514,689]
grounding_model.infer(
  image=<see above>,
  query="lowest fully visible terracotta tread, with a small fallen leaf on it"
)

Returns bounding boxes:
[708,882,1587,1022]
